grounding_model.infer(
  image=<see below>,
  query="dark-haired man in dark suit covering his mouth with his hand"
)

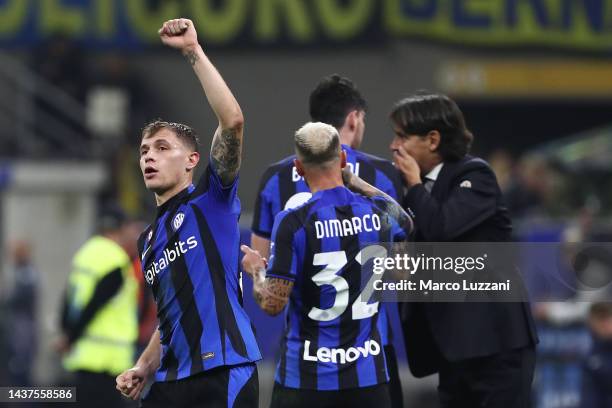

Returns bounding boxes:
[391,94,537,408]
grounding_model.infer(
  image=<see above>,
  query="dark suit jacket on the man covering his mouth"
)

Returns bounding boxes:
[400,156,537,377]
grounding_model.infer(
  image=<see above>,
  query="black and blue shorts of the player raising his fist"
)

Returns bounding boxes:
[140,364,259,408]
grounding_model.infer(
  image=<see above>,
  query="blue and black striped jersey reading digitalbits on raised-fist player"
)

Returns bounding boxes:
[138,164,261,381]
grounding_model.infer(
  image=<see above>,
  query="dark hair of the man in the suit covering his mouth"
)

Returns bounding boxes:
[390,91,474,161]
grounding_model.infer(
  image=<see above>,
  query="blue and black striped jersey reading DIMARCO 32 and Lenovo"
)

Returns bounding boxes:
[267,187,409,390]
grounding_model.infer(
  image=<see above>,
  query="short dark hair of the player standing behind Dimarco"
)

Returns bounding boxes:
[309,74,367,129]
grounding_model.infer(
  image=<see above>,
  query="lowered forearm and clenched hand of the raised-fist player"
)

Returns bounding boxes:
[116,330,161,400]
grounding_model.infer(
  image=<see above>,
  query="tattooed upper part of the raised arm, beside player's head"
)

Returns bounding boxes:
[210,129,242,185]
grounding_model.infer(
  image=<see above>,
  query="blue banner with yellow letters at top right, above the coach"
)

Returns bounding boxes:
[382,0,612,51]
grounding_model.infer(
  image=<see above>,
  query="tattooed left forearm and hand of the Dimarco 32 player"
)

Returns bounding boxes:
[240,245,293,316]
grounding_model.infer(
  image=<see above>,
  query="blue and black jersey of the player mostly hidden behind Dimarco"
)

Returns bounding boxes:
[251,145,403,345]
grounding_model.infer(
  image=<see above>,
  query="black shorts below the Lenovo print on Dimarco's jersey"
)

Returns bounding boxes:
[270,383,391,408]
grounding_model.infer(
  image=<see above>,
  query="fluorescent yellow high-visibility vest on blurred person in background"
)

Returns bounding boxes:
[63,236,138,375]
